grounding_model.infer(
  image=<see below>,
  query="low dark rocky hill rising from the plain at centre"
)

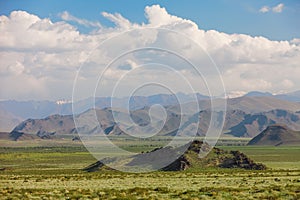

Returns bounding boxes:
[83,140,266,172]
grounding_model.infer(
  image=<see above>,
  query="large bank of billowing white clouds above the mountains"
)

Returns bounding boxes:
[0,4,300,100]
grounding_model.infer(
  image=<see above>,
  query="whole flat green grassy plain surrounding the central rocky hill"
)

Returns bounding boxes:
[0,139,300,199]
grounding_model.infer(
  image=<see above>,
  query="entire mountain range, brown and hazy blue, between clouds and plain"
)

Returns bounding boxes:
[0,92,300,139]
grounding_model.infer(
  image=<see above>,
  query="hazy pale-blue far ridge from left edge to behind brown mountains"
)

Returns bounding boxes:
[0,93,209,131]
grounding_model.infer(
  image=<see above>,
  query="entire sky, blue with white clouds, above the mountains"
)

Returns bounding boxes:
[0,0,300,100]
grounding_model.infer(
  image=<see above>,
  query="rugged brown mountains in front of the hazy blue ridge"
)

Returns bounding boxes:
[11,107,300,138]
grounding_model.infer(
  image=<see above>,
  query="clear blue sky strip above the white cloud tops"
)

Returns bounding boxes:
[0,0,300,40]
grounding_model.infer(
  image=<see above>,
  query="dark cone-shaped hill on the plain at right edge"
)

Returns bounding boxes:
[248,124,300,146]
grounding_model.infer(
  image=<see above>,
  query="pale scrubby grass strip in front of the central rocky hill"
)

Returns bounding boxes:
[0,170,300,199]
